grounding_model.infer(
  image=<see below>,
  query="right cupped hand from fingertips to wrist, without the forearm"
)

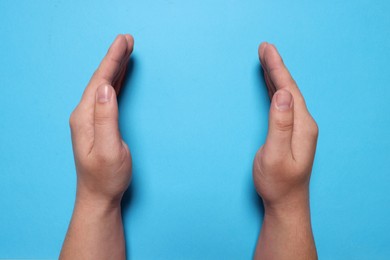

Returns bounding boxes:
[253,43,318,214]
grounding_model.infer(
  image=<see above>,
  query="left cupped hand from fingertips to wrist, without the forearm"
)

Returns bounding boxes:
[70,35,134,205]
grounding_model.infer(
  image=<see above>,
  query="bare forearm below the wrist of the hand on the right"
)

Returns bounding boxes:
[255,192,317,260]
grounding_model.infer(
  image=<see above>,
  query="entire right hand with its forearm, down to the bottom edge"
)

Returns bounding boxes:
[253,43,318,260]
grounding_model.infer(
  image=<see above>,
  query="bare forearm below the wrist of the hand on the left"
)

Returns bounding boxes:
[60,196,126,260]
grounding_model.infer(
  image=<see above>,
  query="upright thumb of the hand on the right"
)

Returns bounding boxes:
[264,89,294,159]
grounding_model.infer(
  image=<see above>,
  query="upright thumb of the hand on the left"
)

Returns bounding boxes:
[94,85,122,155]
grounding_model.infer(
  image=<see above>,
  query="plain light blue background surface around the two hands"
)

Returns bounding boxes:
[0,0,390,259]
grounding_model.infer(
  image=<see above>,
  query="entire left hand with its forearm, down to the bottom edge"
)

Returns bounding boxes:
[60,35,134,259]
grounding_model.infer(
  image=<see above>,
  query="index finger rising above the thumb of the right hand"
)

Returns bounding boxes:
[259,43,307,112]
